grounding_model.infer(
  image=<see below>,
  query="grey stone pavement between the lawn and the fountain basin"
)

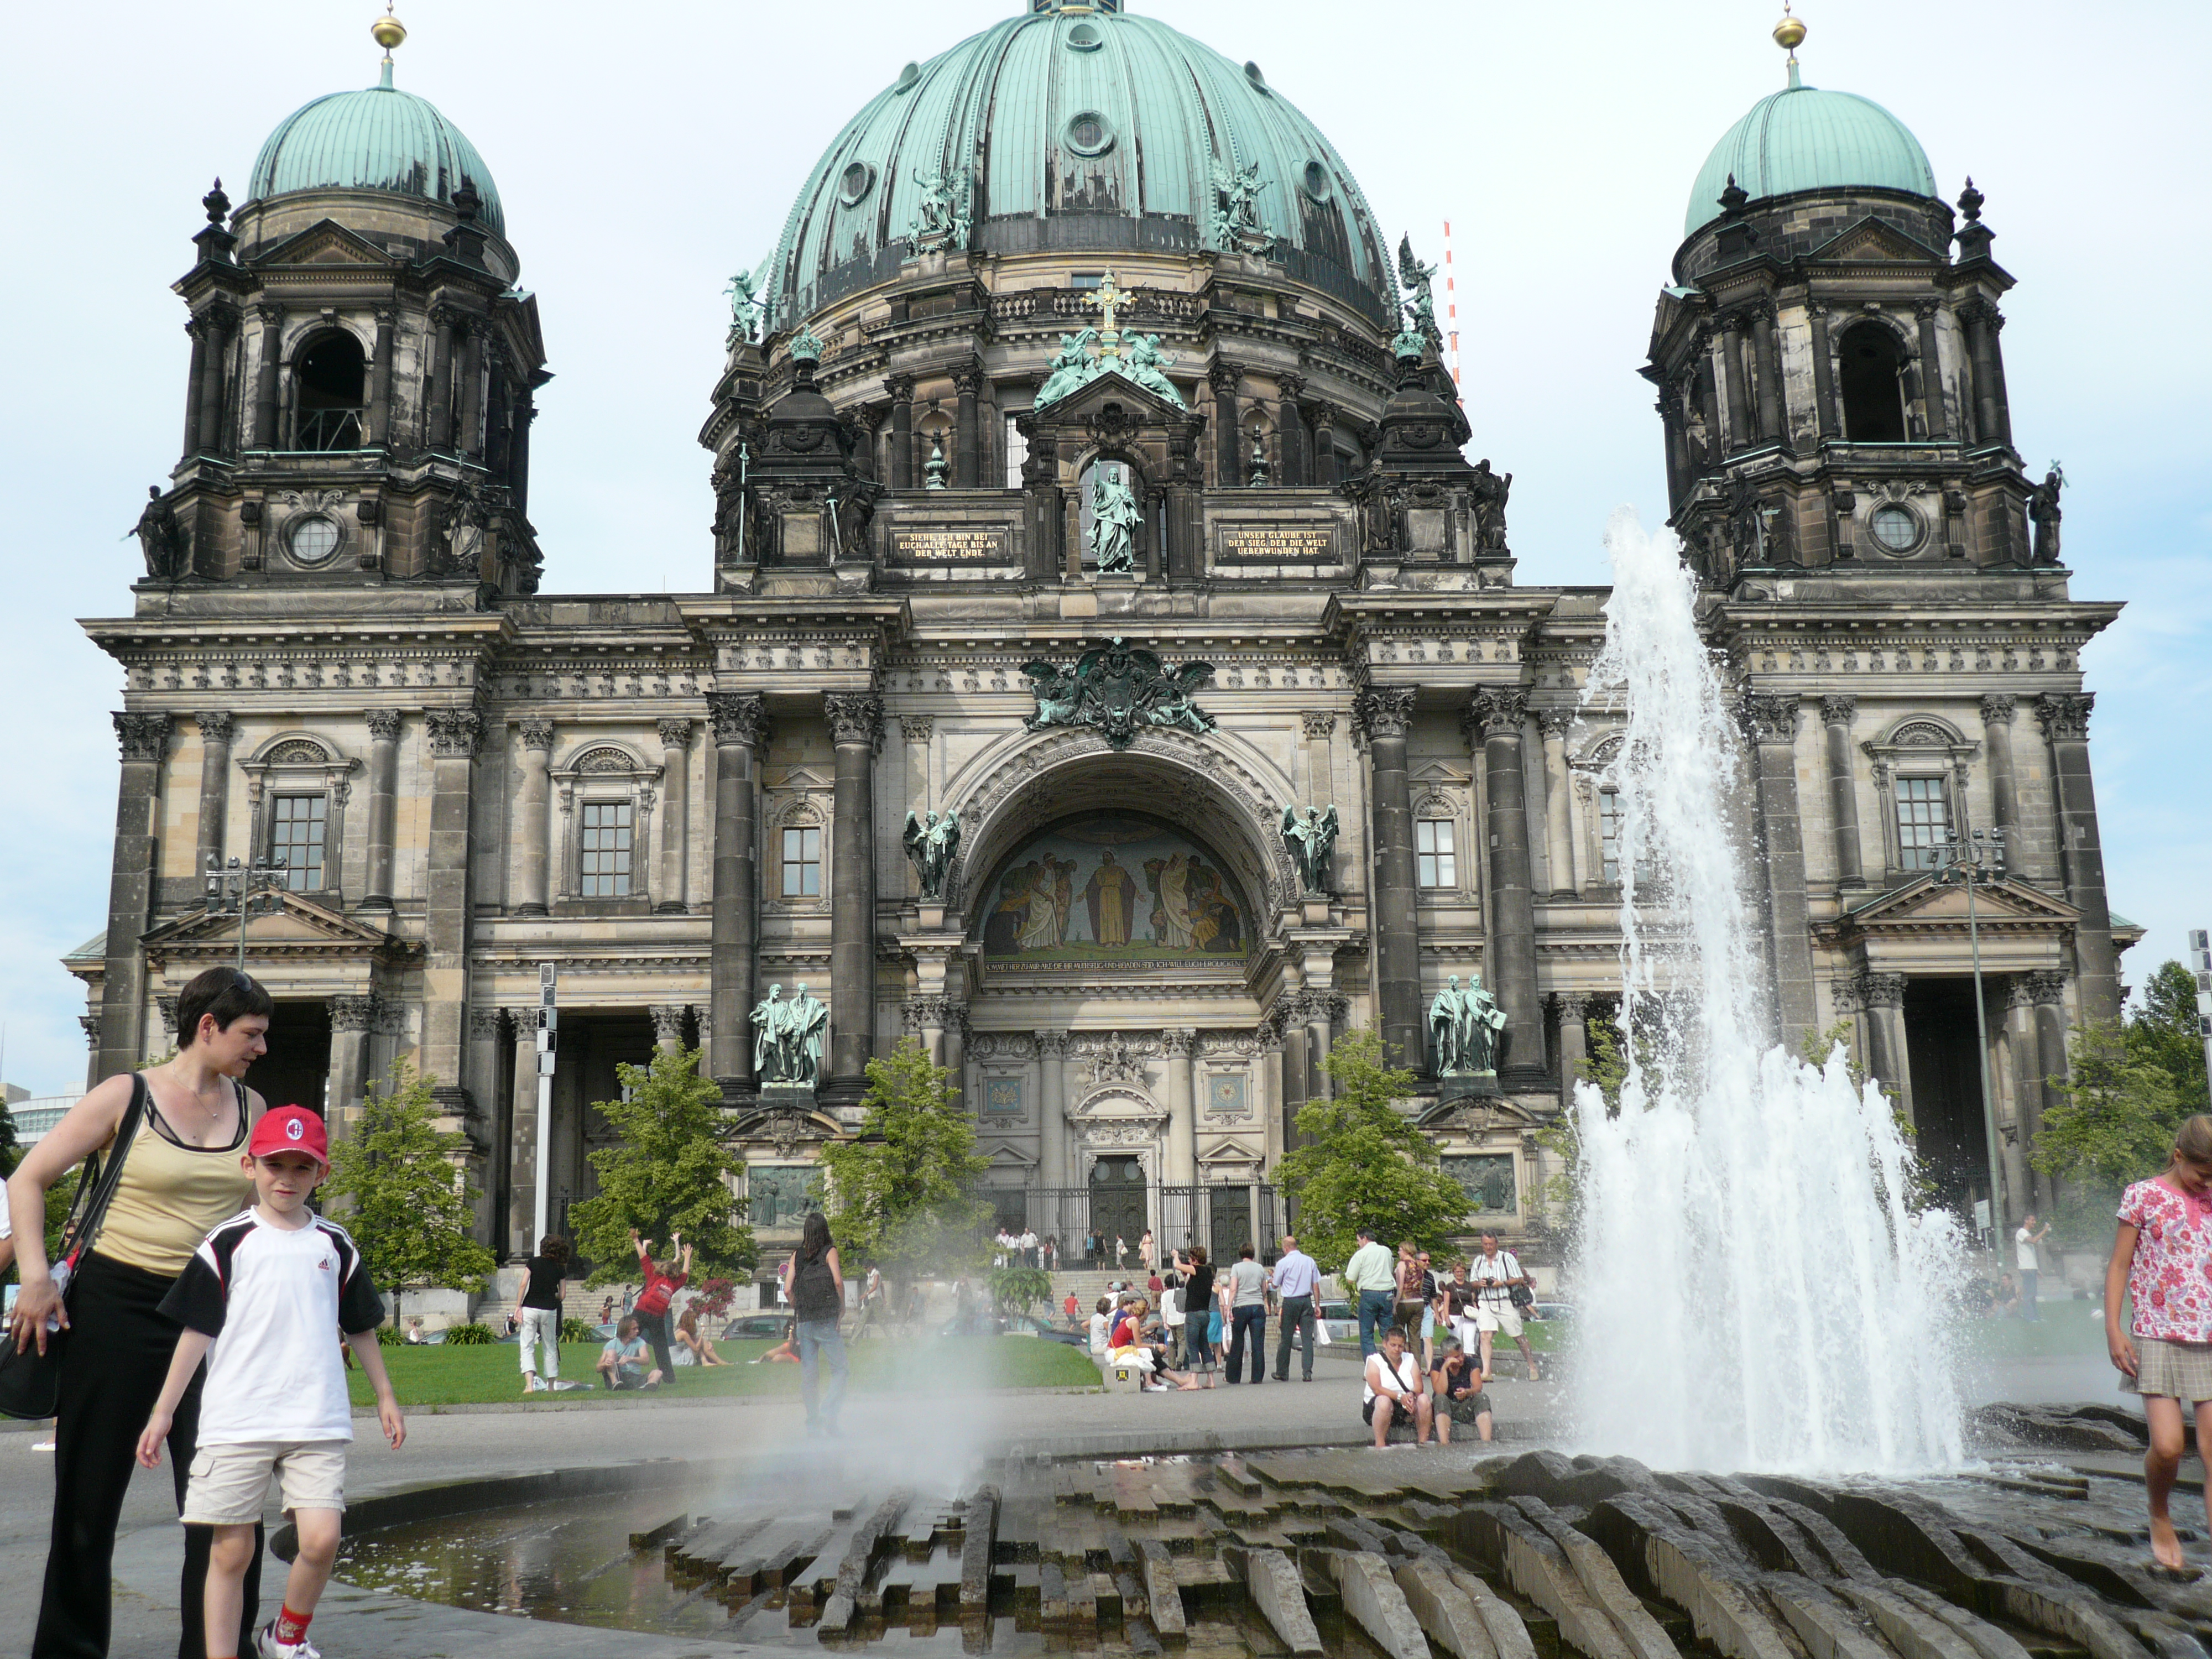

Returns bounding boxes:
[0,1349,1555,1659]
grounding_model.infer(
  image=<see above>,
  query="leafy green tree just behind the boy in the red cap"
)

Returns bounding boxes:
[323,1060,493,1292]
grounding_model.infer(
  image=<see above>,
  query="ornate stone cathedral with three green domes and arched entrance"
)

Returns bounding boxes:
[82,0,2139,1263]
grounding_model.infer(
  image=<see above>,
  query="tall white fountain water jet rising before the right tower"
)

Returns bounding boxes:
[1573,509,1964,1475]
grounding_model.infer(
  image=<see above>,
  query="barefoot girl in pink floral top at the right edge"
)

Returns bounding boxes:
[2104,1115,2212,1573]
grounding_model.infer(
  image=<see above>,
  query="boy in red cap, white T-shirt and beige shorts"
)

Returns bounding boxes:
[139,1106,407,1659]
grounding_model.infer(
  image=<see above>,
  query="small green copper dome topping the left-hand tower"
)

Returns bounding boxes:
[246,64,507,234]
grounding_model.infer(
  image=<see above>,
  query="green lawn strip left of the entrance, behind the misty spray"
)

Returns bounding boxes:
[345,1336,1099,1407]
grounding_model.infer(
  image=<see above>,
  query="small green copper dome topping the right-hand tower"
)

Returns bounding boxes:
[1681,82,1936,237]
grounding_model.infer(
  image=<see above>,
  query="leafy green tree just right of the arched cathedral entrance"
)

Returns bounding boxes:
[1276,1031,1473,1267]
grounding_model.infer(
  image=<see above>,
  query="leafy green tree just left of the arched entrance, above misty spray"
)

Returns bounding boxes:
[823,1037,991,1292]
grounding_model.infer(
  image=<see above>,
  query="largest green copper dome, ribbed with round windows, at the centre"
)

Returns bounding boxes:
[768,0,1396,327]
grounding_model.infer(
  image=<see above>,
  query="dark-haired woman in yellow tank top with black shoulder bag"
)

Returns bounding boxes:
[7,969,274,1659]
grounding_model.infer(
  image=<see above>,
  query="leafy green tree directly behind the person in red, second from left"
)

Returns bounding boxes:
[568,1048,761,1285]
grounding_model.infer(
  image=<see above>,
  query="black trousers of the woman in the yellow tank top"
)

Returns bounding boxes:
[31,1252,261,1659]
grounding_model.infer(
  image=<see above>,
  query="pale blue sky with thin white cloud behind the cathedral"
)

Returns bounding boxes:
[0,0,2212,1095]
